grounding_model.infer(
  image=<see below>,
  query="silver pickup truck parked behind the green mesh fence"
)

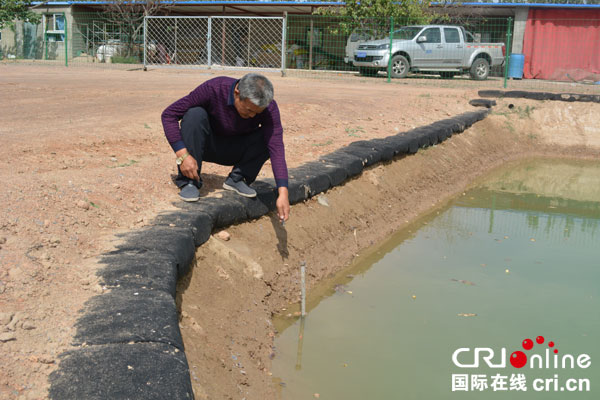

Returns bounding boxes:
[352,25,506,80]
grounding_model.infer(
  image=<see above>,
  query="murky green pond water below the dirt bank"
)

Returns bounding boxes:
[273,160,600,400]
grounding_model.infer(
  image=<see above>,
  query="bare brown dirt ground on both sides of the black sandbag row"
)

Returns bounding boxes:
[0,64,600,399]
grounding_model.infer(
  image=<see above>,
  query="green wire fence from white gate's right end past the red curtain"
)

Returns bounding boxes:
[285,15,600,93]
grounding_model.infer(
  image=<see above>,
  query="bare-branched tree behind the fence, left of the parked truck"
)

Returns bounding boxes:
[102,0,174,57]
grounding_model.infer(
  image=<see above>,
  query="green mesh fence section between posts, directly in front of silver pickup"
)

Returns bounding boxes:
[286,15,512,77]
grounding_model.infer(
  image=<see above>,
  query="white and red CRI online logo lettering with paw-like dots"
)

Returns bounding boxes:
[452,336,591,369]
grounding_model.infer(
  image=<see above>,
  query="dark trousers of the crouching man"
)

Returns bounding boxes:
[175,107,269,187]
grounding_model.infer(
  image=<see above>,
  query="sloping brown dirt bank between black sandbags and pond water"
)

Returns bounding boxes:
[178,99,600,399]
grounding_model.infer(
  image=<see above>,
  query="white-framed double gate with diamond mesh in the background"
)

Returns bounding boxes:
[144,17,285,69]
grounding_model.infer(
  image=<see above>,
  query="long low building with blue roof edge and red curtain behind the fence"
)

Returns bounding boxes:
[0,0,600,80]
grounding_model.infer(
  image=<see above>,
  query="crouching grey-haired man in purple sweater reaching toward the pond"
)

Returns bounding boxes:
[162,74,290,221]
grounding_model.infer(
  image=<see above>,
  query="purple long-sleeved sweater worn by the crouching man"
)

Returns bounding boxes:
[161,76,288,187]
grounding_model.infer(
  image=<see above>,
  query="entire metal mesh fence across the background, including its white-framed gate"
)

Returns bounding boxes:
[0,11,600,93]
